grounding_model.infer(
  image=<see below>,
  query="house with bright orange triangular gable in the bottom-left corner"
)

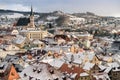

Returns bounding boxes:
[0,62,20,80]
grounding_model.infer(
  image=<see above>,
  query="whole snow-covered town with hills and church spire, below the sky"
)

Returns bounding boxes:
[0,6,120,80]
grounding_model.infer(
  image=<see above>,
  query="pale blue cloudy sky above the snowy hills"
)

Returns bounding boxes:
[0,0,120,17]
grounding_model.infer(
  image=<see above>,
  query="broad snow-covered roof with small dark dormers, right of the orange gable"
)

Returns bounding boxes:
[20,62,63,80]
